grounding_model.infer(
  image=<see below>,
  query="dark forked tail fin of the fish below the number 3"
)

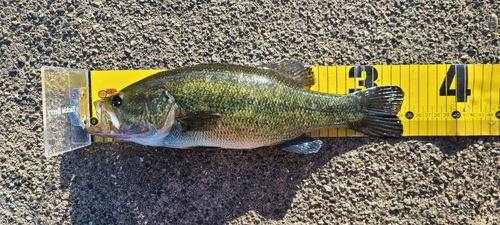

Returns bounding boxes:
[348,86,404,137]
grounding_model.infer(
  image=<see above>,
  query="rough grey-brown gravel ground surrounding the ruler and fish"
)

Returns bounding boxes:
[0,0,500,224]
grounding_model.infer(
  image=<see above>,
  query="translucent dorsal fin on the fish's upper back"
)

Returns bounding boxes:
[256,60,314,87]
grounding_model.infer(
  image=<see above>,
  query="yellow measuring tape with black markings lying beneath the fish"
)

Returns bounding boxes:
[90,64,500,142]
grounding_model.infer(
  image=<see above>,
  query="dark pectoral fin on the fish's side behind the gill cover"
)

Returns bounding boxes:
[177,111,221,132]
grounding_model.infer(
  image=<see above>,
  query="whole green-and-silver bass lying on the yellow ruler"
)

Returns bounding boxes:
[87,60,404,154]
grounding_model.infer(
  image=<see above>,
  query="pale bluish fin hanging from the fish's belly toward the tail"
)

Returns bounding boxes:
[276,135,323,154]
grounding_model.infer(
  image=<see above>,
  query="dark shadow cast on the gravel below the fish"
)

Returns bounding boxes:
[61,138,366,224]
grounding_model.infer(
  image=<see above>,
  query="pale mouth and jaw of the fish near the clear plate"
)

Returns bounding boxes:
[87,101,121,138]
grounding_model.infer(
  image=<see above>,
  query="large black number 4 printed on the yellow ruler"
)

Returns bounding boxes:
[439,65,470,102]
